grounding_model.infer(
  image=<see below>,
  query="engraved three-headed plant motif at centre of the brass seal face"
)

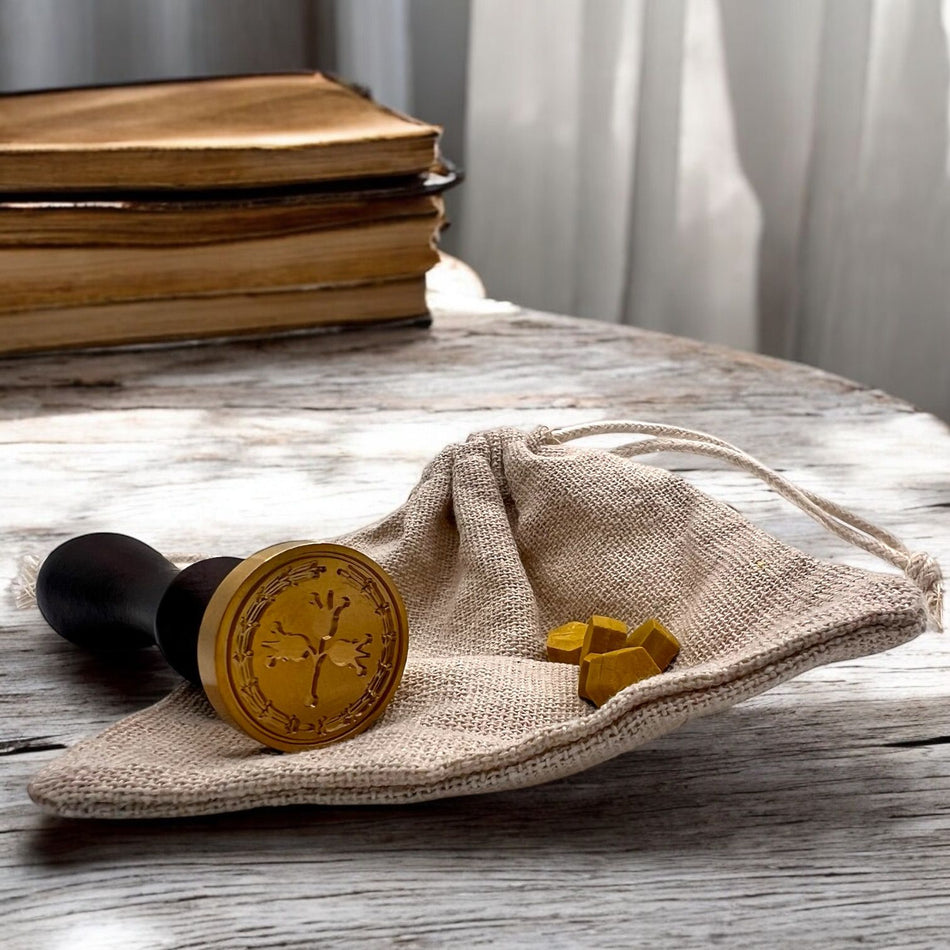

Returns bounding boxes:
[261,589,372,708]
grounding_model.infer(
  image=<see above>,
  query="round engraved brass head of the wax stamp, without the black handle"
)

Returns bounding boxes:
[198,542,409,752]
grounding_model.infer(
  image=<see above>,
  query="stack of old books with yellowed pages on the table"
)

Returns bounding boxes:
[0,74,453,352]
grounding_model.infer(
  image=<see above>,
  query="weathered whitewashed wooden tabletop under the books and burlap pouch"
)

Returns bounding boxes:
[0,298,950,950]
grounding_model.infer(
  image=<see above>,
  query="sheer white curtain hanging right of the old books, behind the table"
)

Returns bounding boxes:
[460,0,950,417]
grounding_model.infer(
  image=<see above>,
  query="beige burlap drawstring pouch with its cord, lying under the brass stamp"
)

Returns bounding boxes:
[30,423,940,818]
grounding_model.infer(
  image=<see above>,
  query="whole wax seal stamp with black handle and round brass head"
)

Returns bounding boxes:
[36,534,409,752]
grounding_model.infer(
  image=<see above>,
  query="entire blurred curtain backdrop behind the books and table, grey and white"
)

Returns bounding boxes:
[0,0,950,420]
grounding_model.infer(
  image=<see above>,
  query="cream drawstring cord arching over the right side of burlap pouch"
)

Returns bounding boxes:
[538,420,943,630]
